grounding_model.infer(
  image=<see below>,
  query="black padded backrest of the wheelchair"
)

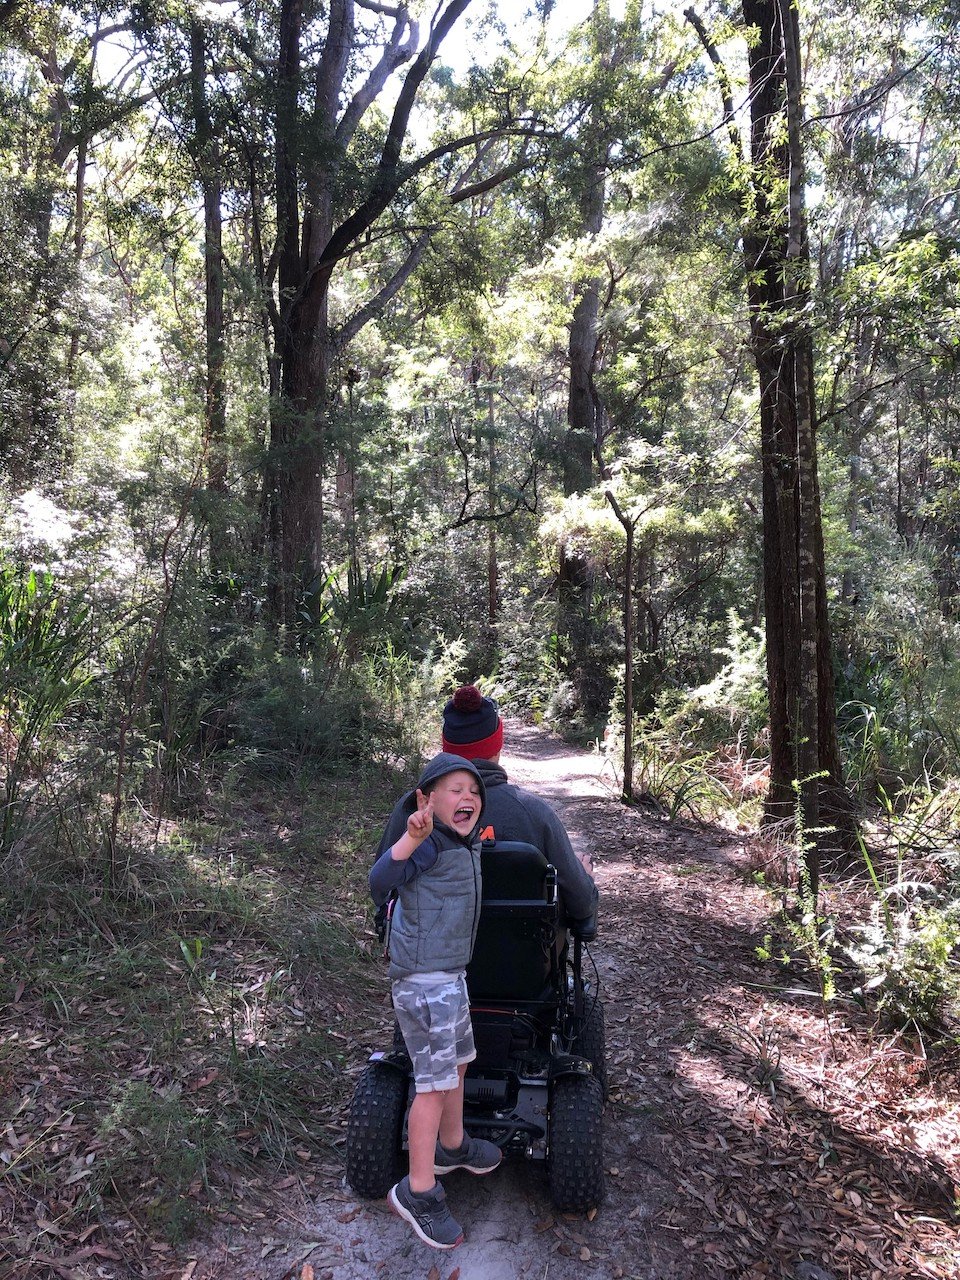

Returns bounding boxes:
[467,840,566,1004]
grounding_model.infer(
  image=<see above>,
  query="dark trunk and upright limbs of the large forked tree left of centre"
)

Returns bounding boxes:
[265,0,476,625]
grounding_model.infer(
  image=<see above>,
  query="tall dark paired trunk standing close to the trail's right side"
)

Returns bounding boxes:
[742,0,850,895]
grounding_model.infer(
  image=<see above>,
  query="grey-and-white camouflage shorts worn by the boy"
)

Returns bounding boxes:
[392,973,476,1093]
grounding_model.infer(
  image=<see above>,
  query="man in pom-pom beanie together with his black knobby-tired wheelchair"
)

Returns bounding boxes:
[347,686,605,1243]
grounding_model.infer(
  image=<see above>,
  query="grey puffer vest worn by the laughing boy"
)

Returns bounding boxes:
[389,823,480,978]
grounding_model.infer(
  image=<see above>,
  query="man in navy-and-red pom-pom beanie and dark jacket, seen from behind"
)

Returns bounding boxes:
[378,685,598,920]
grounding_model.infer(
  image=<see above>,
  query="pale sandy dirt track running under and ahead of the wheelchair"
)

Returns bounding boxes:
[244,724,680,1280]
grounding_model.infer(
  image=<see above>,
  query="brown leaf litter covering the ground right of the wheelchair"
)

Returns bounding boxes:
[594,823,957,1280]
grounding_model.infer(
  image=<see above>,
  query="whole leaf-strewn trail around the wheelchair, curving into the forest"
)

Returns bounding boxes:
[0,724,960,1280]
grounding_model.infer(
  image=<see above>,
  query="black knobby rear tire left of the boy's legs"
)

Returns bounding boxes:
[346,1062,407,1199]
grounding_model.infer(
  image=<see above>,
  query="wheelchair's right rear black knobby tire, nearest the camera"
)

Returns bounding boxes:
[548,1075,604,1213]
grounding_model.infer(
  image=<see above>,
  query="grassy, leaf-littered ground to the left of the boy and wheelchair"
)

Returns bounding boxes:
[0,757,396,1260]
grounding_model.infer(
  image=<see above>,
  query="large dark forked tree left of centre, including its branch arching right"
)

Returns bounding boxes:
[217,0,560,622]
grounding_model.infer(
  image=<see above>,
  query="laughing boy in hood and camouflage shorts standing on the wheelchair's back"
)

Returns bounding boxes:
[370,753,502,1249]
